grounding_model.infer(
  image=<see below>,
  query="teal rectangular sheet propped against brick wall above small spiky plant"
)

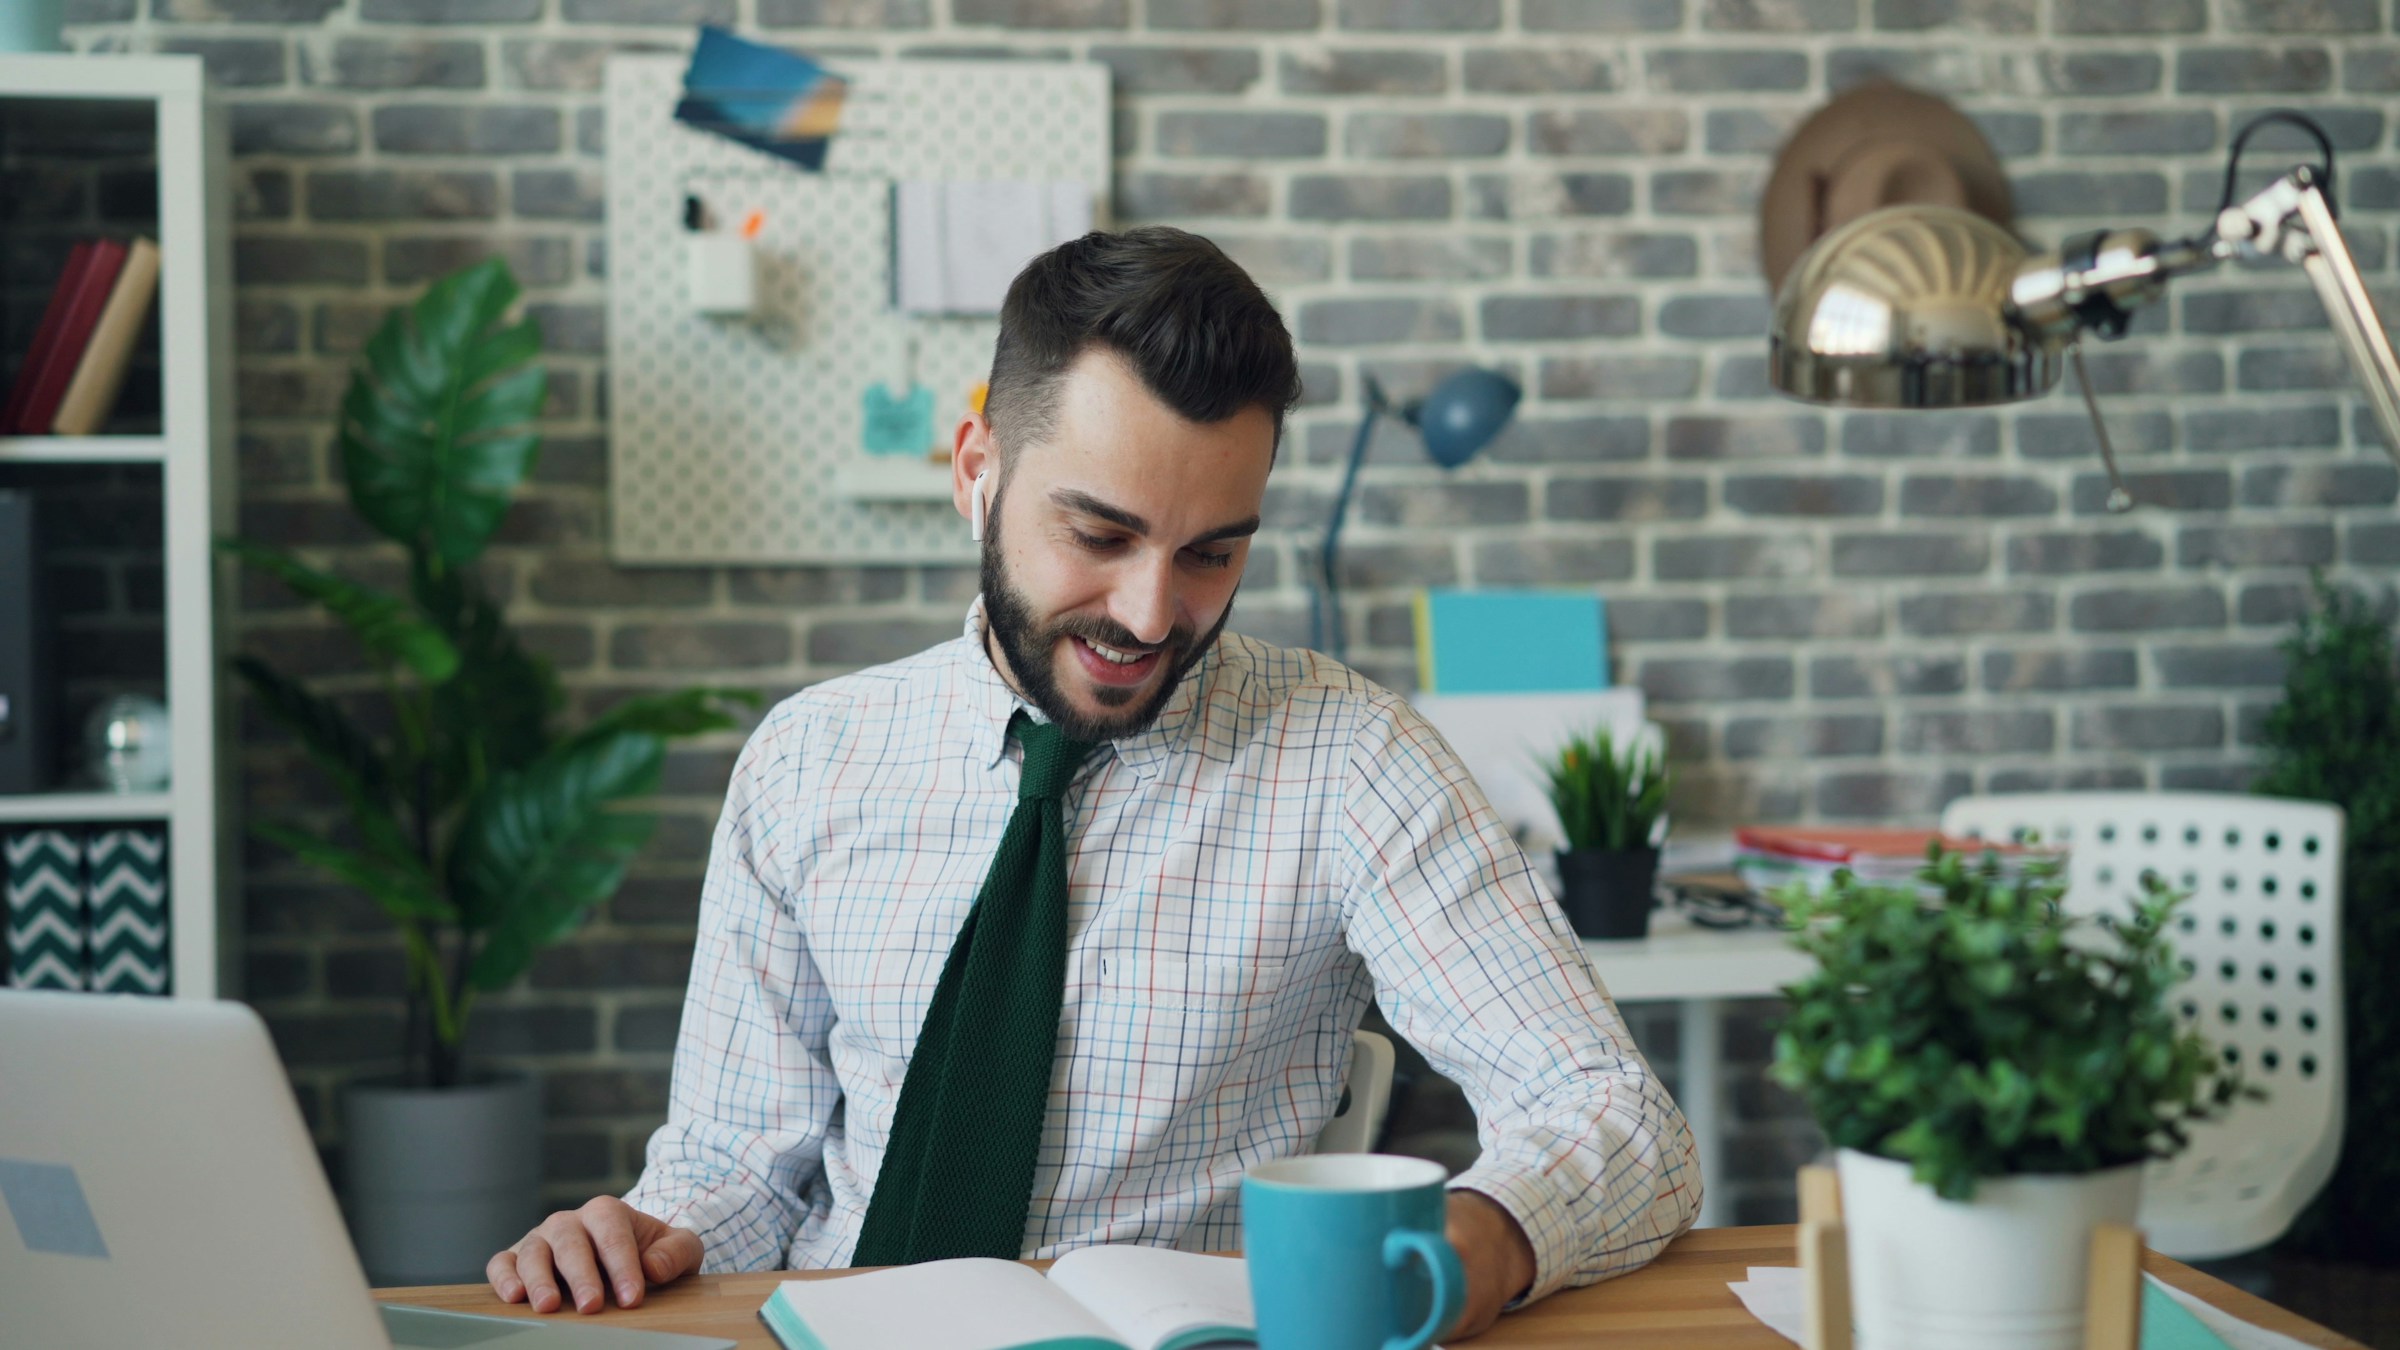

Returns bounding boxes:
[1416,591,1608,694]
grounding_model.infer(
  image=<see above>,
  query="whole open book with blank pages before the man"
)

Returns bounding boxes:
[758,1247,1258,1350]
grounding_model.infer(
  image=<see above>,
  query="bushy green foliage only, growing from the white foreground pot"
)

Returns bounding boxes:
[1771,841,2246,1199]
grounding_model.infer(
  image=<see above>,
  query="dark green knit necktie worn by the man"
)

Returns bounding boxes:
[850,711,1092,1266]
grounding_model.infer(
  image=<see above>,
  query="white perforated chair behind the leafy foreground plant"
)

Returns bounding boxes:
[1942,793,2345,1261]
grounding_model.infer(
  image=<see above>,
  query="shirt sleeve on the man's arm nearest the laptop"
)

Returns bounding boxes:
[624,701,840,1273]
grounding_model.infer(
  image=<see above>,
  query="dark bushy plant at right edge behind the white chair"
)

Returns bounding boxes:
[2251,577,2400,1264]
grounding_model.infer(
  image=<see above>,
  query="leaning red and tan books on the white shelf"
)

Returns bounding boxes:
[0,238,158,435]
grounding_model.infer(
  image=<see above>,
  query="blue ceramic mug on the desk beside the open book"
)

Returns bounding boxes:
[1241,1153,1466,1350]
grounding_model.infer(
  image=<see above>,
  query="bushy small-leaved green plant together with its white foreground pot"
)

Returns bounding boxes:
[1771,841,2246,1350]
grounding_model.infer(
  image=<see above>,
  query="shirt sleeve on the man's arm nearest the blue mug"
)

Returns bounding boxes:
[1342,694,1699,1307]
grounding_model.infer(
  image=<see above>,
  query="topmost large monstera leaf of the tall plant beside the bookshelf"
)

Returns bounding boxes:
[341,259,550,569]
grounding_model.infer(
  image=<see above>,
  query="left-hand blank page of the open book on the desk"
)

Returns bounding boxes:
[758,1256,1130,1350]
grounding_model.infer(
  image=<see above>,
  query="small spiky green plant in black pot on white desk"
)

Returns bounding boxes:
[1543,728,1668,937]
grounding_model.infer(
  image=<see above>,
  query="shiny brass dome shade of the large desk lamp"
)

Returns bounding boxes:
[1766,204,2059,408]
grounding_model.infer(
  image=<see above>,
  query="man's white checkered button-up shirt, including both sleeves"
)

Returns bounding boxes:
[626,605,1699,1297]
